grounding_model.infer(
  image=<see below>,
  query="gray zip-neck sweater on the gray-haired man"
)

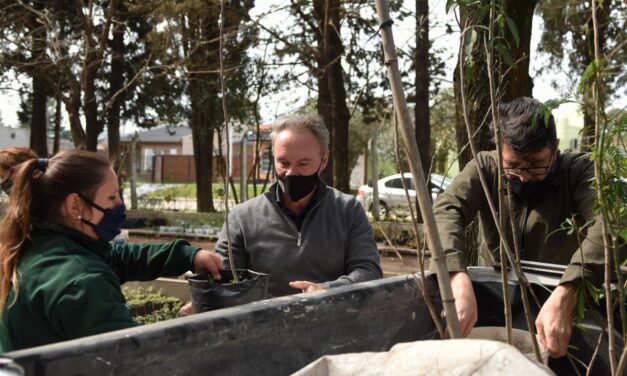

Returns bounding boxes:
[216,183,382,296]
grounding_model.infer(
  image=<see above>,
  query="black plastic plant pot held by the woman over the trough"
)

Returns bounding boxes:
[187,269,270,313]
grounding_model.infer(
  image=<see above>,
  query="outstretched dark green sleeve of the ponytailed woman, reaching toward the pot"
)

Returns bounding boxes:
[108,240,199,283]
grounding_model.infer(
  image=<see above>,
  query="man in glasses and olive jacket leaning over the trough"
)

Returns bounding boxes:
[434,97,620,357]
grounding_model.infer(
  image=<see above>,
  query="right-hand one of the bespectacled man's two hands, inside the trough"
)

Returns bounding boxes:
[536,283,577,358]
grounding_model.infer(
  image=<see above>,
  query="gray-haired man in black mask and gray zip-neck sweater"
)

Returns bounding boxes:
[216,116,382,296]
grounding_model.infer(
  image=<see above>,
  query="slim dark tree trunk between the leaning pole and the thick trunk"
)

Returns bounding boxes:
[414,0,431,181]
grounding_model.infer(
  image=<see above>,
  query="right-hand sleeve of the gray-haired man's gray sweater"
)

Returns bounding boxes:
[323,200,383,288]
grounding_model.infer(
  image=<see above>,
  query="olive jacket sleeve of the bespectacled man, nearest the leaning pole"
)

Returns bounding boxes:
[429,154,490,274]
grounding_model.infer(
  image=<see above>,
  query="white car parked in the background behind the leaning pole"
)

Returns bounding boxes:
[357,172,451,219]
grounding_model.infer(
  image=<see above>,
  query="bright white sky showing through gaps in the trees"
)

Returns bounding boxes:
[0,0,627,133]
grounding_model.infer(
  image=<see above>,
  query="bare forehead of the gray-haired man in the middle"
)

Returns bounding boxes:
[274,130,320,159]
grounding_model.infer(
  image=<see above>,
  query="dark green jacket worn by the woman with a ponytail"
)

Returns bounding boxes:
[0,228,197,352]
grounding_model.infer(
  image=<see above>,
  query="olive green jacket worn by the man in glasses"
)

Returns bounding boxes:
[431,151,603,283]
